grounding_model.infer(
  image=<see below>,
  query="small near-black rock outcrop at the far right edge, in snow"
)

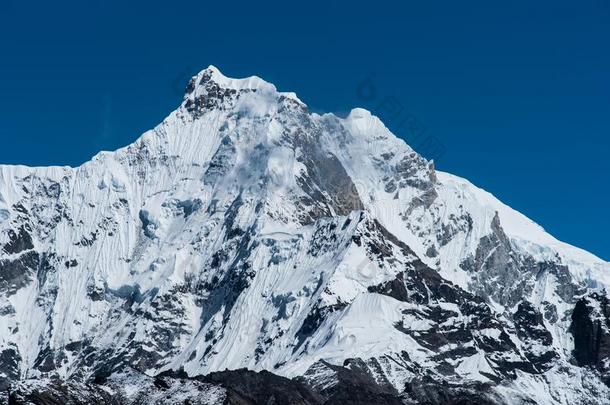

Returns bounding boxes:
[570,293,610,385]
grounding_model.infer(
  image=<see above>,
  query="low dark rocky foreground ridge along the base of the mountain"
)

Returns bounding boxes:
[0,359,520,405]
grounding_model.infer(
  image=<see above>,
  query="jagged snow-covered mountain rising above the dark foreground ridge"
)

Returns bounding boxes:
[0,67,610,404]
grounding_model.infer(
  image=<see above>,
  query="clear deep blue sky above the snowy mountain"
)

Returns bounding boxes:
[0,0,610,259]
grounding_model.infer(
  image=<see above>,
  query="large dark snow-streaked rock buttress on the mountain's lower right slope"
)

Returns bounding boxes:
[369,262,540,382]
